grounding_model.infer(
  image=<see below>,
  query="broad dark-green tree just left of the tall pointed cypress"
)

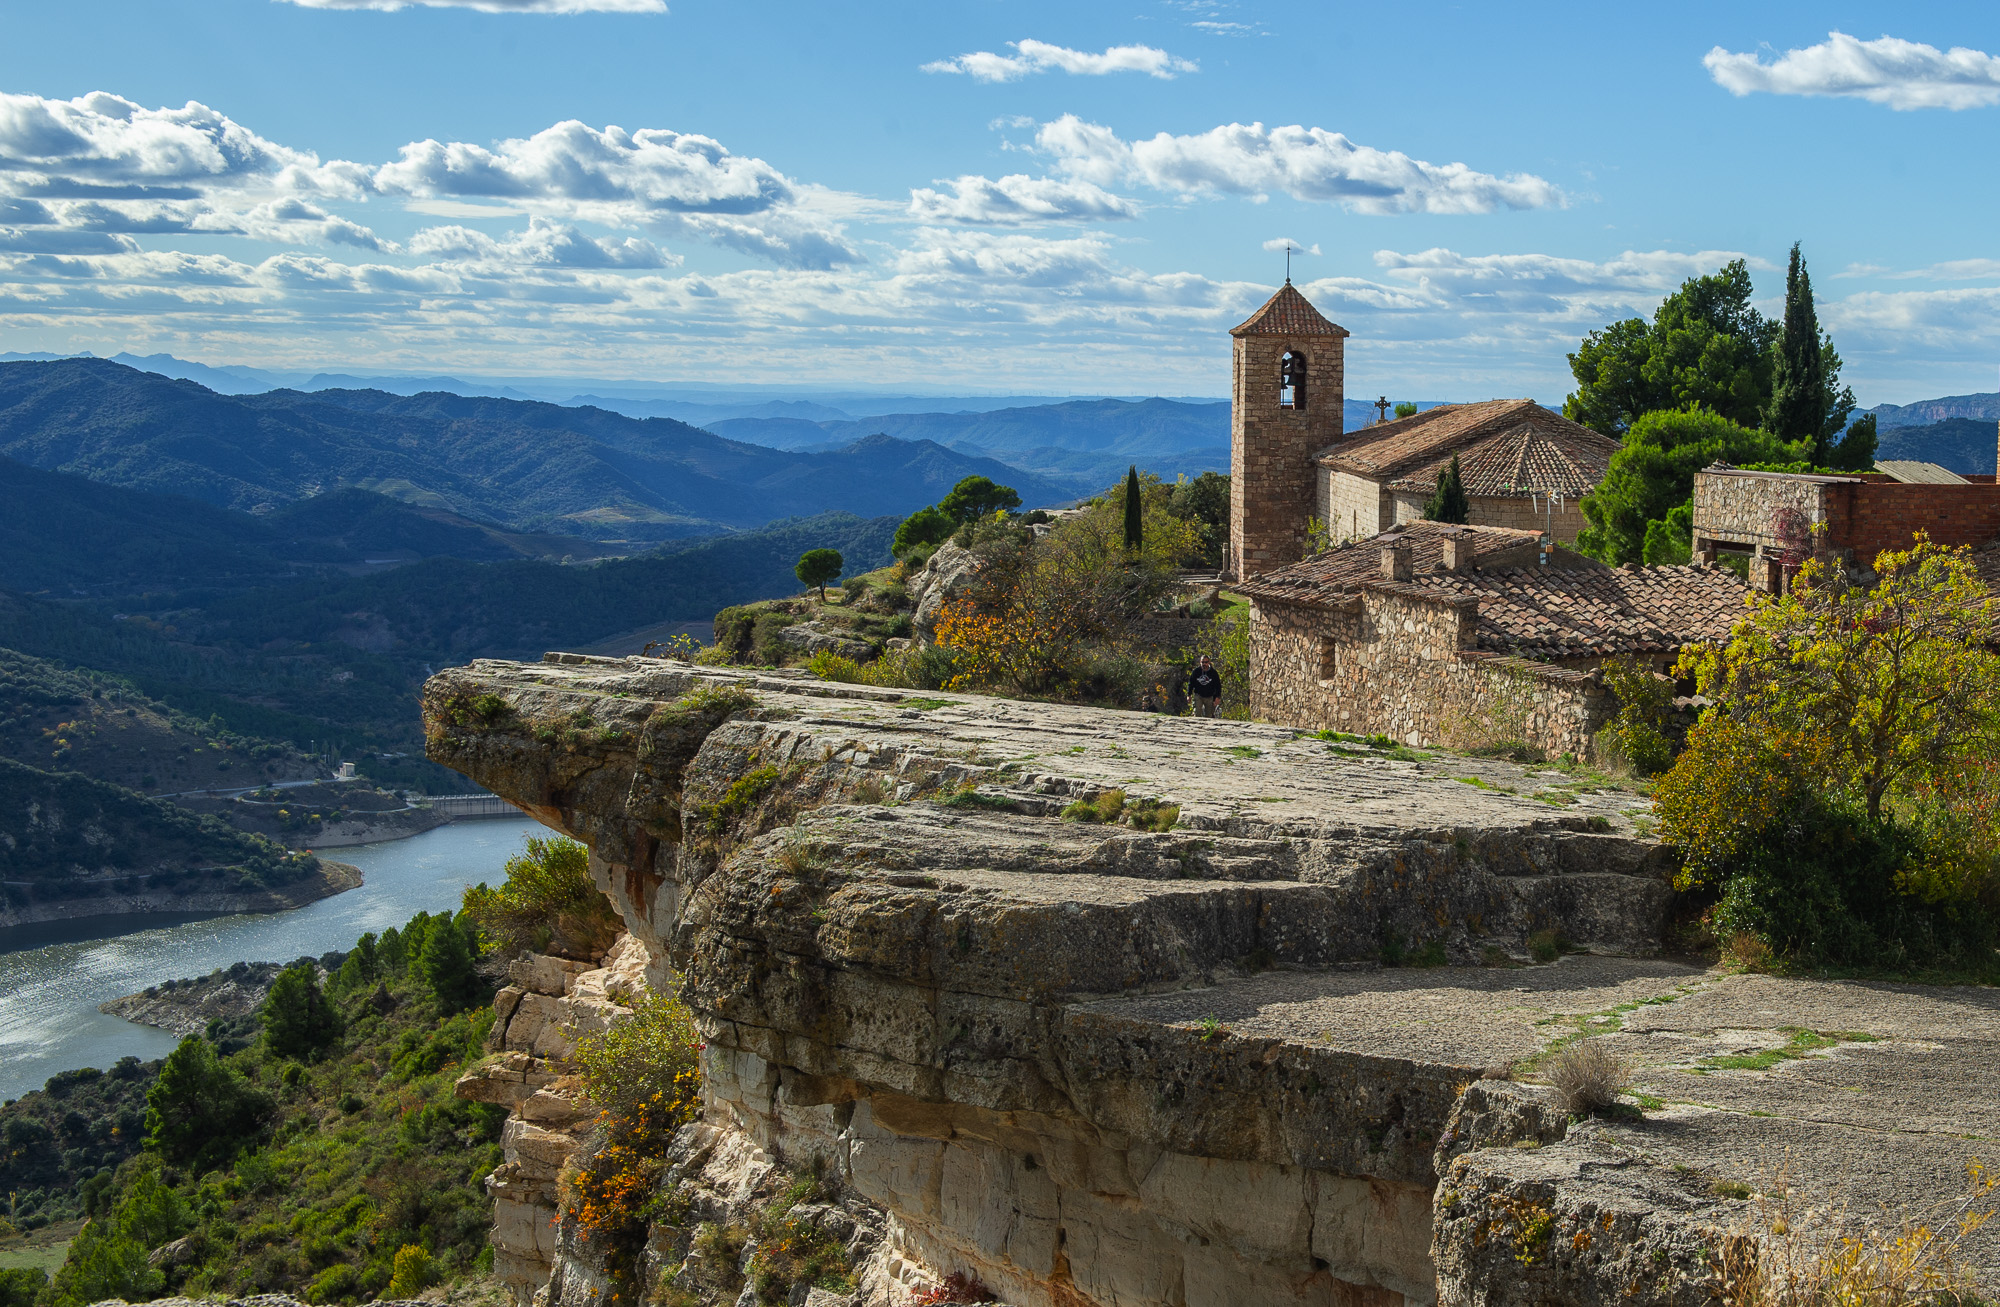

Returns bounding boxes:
[1562,260,1772,436]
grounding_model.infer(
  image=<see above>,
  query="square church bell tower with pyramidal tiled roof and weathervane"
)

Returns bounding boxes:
[1224,278,1348,580]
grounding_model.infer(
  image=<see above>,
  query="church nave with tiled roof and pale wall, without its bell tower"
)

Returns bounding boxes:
[1314,400,1618,542]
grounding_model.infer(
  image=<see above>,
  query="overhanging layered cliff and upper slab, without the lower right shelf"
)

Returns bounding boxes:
[426,655,1678,1307]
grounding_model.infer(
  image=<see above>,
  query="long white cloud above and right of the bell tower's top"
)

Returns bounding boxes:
[1036,114,1566,214]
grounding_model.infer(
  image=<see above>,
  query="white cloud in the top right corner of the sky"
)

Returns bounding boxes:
[1702,32,2000,110]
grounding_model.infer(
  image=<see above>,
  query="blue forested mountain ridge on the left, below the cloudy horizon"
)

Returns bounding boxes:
[0,360,1074,542]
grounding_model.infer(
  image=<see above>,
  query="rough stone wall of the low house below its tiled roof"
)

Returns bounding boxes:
[1250,584,1616,757]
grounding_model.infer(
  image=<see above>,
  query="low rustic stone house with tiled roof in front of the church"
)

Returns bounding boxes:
[1236,522,1746,757]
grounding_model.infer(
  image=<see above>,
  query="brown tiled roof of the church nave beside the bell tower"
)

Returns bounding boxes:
[1320,400,1618,500]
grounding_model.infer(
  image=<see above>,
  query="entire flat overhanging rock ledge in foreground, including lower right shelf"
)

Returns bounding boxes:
[424,654,2000,1307]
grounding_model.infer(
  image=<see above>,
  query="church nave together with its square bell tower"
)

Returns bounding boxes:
[1228,282,1618,578]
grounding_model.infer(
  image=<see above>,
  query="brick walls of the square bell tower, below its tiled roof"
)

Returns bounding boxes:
[1228,336,1346,576]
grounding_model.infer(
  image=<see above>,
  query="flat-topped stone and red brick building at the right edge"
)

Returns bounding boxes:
[1694,455,2000,592]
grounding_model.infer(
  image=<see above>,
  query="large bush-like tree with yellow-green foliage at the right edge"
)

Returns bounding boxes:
[1654,536,2000,969]
